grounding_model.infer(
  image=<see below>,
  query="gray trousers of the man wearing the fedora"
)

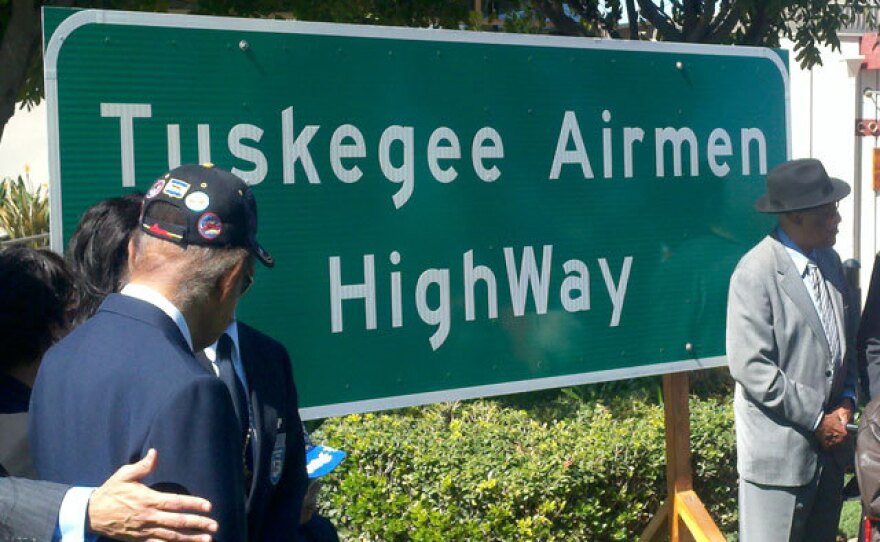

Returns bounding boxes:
[739,454,843,542]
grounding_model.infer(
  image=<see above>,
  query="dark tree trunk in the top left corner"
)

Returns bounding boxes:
[0,0,40,142]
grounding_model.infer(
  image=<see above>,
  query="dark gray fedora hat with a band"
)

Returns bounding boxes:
[755,158,850,213]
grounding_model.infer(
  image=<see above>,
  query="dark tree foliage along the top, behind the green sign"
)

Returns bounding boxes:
[0,0,880,144]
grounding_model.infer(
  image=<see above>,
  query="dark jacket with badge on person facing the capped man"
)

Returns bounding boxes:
[238,321,308,542]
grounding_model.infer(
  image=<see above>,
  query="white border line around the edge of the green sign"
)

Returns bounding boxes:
[43,8,791,420]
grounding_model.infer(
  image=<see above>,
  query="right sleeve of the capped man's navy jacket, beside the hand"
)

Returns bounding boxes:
[142,376,247,542]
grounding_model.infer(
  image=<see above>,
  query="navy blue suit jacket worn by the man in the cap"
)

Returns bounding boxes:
[30,294,247,542]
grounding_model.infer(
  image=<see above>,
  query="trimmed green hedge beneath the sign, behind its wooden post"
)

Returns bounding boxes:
[314,399,737,542]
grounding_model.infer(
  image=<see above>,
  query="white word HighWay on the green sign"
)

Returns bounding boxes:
[329,245,633,350]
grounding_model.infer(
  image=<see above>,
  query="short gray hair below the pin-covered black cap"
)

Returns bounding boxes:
[129,230,253,311]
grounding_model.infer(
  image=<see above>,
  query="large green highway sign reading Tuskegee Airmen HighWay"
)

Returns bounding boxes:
[44,8,791,418]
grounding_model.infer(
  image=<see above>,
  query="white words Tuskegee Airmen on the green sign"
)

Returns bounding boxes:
[101,103,767,209]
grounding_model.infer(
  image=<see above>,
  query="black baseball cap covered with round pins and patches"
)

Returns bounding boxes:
[140,163,275,267]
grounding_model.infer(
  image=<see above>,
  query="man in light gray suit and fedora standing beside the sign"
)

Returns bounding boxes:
[727,159,857,542]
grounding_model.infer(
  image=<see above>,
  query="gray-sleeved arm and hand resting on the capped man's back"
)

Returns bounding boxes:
[0,450,217,542]
